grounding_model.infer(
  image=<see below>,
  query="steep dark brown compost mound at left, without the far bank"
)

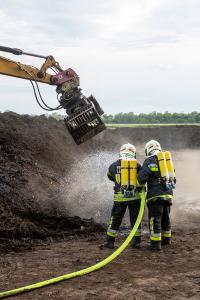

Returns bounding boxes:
[0,112,102,250]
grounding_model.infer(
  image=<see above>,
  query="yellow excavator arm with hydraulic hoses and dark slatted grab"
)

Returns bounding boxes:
[0,46,106,145]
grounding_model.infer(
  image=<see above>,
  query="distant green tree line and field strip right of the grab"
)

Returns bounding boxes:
[103,111,200,124]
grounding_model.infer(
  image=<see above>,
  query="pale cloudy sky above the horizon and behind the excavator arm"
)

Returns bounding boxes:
[0,0,200,114]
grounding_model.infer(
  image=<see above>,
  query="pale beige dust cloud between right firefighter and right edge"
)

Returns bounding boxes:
[172,149,200,227]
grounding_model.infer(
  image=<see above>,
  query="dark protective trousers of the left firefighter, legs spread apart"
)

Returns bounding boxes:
[107,200,141,240]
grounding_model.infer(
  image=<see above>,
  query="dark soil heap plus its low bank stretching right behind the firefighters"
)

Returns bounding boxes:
[0,112,200,249]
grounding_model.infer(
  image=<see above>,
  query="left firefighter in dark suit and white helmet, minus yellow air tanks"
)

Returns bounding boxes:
[104,143,141,249]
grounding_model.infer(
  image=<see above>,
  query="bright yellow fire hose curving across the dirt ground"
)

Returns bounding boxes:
[0,189,145,299]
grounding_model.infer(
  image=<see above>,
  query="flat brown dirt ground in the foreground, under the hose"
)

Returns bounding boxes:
[0,229,200,300]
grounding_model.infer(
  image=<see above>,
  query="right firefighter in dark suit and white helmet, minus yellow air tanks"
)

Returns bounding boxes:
[138,140,173,250]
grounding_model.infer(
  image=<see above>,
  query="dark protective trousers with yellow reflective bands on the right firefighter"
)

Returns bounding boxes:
[148,201,171,244]
